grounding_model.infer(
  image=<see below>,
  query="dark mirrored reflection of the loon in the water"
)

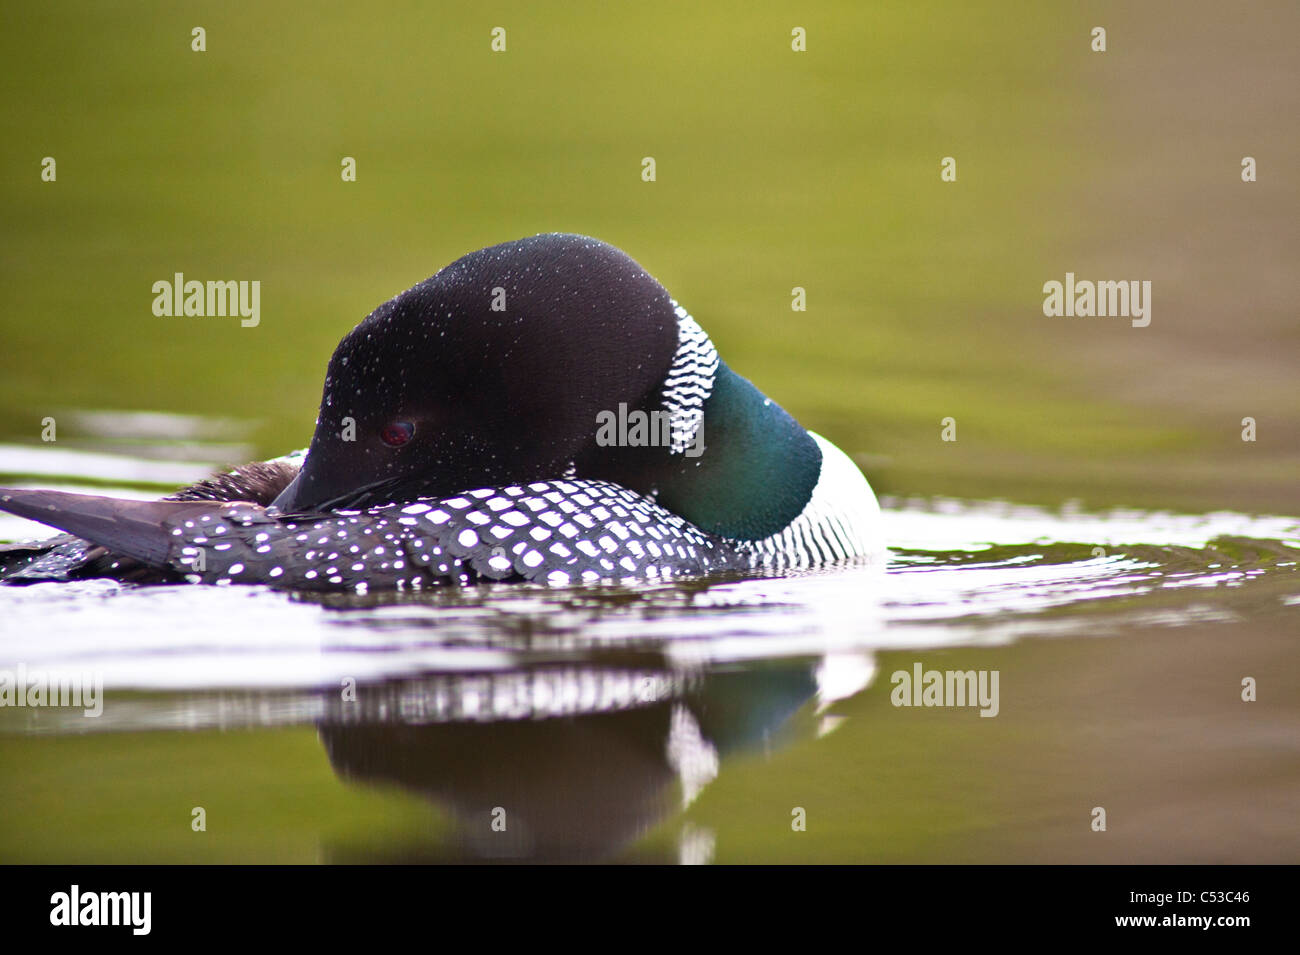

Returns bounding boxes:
[319,660,847,863]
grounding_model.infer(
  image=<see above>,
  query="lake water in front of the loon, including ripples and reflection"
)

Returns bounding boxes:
[0,433,1300,861]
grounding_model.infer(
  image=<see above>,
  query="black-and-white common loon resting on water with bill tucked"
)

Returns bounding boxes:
[0,234,881,591]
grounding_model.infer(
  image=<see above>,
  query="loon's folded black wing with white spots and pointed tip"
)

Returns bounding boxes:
[0,479,749,590]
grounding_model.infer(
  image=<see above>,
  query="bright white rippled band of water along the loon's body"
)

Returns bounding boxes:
[0,444,1300,720]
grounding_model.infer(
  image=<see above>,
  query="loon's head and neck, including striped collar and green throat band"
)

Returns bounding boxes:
[274,234,820,539]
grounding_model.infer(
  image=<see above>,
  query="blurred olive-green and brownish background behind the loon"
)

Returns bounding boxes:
[0,3,1300,513]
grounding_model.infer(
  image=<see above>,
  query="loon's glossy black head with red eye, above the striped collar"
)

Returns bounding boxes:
[276,234,677,511]
